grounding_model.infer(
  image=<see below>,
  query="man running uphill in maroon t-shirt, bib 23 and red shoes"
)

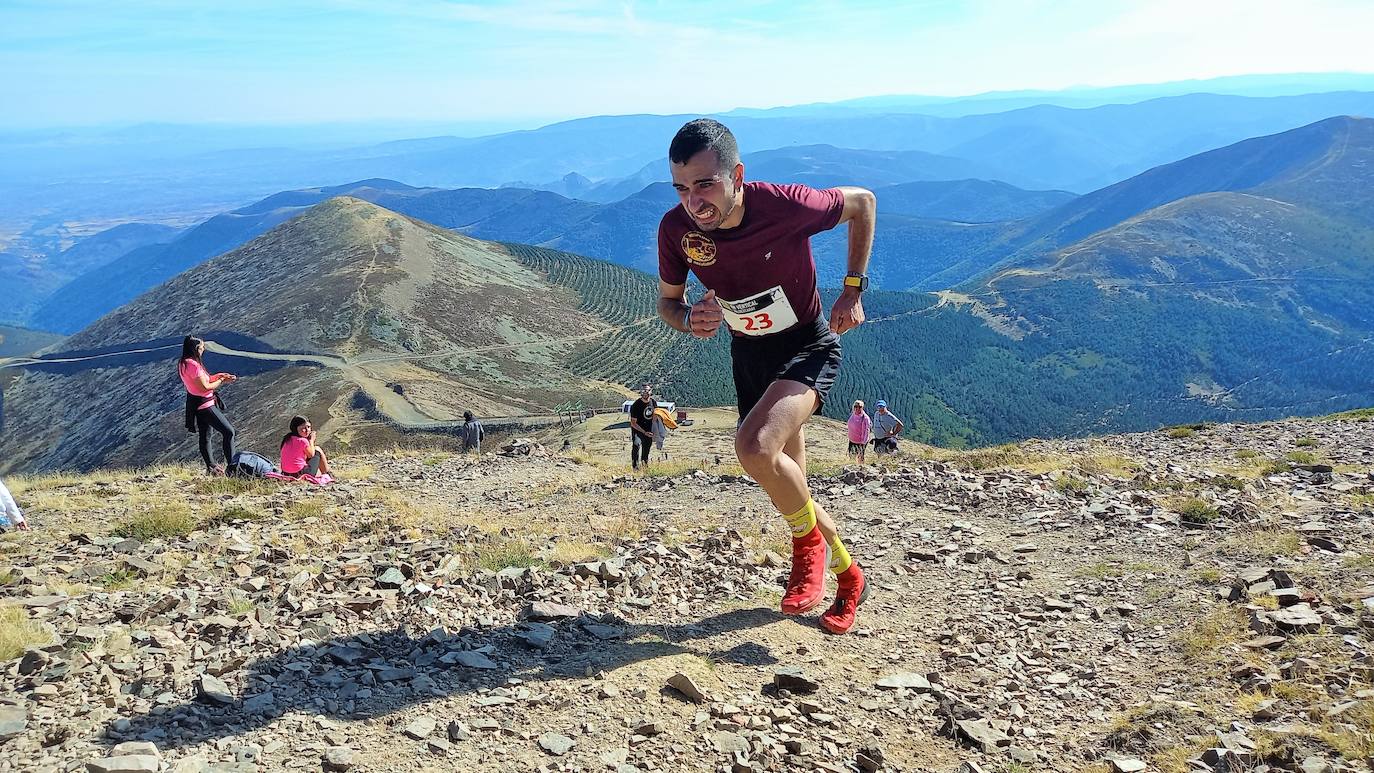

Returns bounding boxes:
[658,118,875,633]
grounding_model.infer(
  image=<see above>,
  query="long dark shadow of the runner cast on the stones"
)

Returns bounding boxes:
[104,608,786,748]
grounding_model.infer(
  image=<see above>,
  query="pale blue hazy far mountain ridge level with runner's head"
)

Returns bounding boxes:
[287,92,1374,192]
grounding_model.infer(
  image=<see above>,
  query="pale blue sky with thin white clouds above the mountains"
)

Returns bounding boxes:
[0,0,1374,128]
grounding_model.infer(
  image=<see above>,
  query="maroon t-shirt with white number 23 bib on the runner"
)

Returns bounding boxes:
[658,183,845,336]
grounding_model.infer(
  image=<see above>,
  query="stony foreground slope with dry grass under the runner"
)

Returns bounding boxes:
[0,422,1374,773]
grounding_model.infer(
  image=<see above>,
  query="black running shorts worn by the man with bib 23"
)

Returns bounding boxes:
[730,317,844,422]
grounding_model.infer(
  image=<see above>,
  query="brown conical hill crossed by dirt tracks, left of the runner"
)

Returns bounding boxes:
[0,196,724,468]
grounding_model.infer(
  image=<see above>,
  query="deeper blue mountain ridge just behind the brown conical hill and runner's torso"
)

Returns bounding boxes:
[26,162,1073,332]
